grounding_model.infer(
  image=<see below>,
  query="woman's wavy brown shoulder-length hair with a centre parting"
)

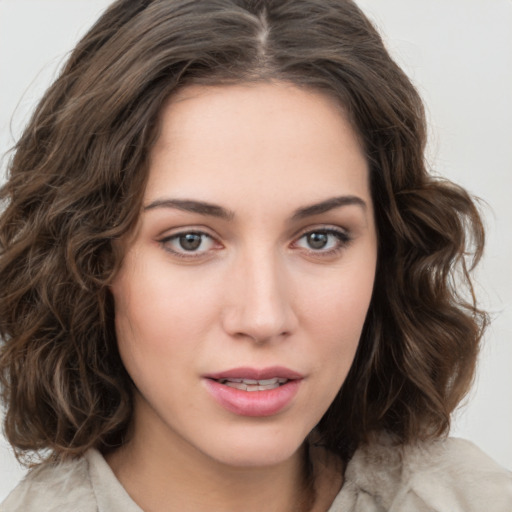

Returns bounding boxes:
[0,0,487,460]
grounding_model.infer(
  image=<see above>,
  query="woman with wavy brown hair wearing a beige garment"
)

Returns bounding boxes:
[0,0,512,512]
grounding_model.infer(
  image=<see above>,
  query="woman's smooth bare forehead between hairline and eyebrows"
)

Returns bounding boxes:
[146,83,369,212]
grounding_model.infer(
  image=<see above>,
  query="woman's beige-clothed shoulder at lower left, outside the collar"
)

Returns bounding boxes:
[0,458,97,512]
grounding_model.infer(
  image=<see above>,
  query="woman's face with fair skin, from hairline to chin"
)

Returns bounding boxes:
[112,83,377,466]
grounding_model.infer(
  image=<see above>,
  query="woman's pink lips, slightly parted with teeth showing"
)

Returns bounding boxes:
[204,366,303,417]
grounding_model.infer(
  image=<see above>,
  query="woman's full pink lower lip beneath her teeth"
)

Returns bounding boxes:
[205,379,301,417]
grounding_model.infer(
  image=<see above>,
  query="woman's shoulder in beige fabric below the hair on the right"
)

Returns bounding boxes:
[340,436,512,512]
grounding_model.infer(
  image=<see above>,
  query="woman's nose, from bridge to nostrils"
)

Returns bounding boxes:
[223,251,297,343]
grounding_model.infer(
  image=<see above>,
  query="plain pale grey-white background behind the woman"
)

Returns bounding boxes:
[0,0,512,501]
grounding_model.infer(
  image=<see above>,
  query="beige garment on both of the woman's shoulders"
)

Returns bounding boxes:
[0,437,512,512]
